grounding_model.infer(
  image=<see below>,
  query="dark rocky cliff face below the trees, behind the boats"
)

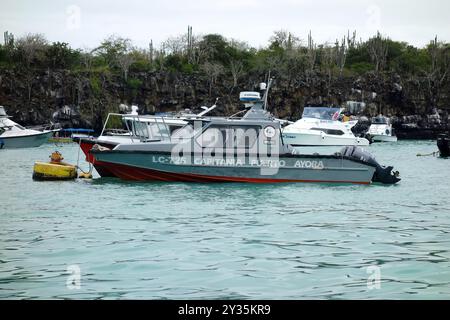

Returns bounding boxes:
[0,69,449,139]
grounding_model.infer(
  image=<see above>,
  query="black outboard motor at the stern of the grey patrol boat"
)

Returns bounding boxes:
[341,146,401,184]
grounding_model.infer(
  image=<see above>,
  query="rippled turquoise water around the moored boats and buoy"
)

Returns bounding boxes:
[0,141,450,299]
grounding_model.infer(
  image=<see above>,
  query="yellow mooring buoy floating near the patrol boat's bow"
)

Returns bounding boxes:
[33,151,77,180]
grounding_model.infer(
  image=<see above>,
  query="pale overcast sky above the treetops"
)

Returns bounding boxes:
[0,0,450,48]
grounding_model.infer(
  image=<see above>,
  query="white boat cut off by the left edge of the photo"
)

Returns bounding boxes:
[0,106,53,149]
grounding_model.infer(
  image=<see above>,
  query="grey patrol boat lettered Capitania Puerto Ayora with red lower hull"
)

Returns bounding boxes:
[89,84,400,184]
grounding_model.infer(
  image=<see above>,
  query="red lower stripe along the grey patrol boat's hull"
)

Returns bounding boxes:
[102,162,370,184]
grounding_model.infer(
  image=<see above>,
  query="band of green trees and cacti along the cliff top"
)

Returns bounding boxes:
[0,31,449,83]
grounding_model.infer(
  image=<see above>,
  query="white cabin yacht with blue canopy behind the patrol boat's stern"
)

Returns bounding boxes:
[283,107,369,146]
